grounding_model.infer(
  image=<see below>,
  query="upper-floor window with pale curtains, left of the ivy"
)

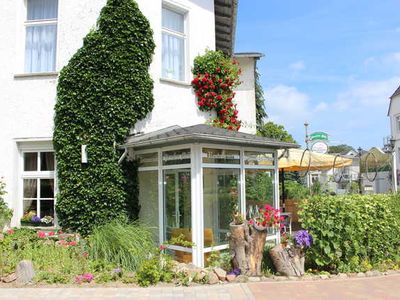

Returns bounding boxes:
[25,0,58,73]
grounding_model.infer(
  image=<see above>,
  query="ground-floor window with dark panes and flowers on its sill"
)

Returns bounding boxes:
[22,151,55,223]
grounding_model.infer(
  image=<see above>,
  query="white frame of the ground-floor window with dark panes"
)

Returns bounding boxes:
[16,139,58,227]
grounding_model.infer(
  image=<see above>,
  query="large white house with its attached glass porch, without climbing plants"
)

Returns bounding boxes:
[0,0,293,265]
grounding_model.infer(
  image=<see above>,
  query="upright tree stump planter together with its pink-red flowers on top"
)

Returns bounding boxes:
[229,204,281,276]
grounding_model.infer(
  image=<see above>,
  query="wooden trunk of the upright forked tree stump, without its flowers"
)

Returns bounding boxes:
[229,224,267,276]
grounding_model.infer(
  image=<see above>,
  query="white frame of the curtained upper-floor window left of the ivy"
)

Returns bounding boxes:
[22,0,60,74]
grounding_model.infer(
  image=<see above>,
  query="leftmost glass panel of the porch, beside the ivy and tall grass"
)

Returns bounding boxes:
[139,171,159,242]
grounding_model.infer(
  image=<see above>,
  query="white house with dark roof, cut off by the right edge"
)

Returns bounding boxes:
[388,86,400,173]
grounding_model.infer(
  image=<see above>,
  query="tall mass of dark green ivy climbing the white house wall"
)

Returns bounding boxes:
[54,0,155,234]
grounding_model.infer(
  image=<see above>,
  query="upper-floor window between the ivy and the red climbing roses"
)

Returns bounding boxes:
[162,7,186,81]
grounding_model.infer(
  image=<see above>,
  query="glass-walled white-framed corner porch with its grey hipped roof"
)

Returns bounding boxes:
[126,125,294,266]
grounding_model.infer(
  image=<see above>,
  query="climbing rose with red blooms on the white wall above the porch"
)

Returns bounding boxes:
[192,50,241,130]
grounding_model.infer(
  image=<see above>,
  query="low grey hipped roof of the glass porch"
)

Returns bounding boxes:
[124,124,299,149]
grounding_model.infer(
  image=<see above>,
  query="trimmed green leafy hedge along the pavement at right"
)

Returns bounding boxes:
[299,195,400,272]
